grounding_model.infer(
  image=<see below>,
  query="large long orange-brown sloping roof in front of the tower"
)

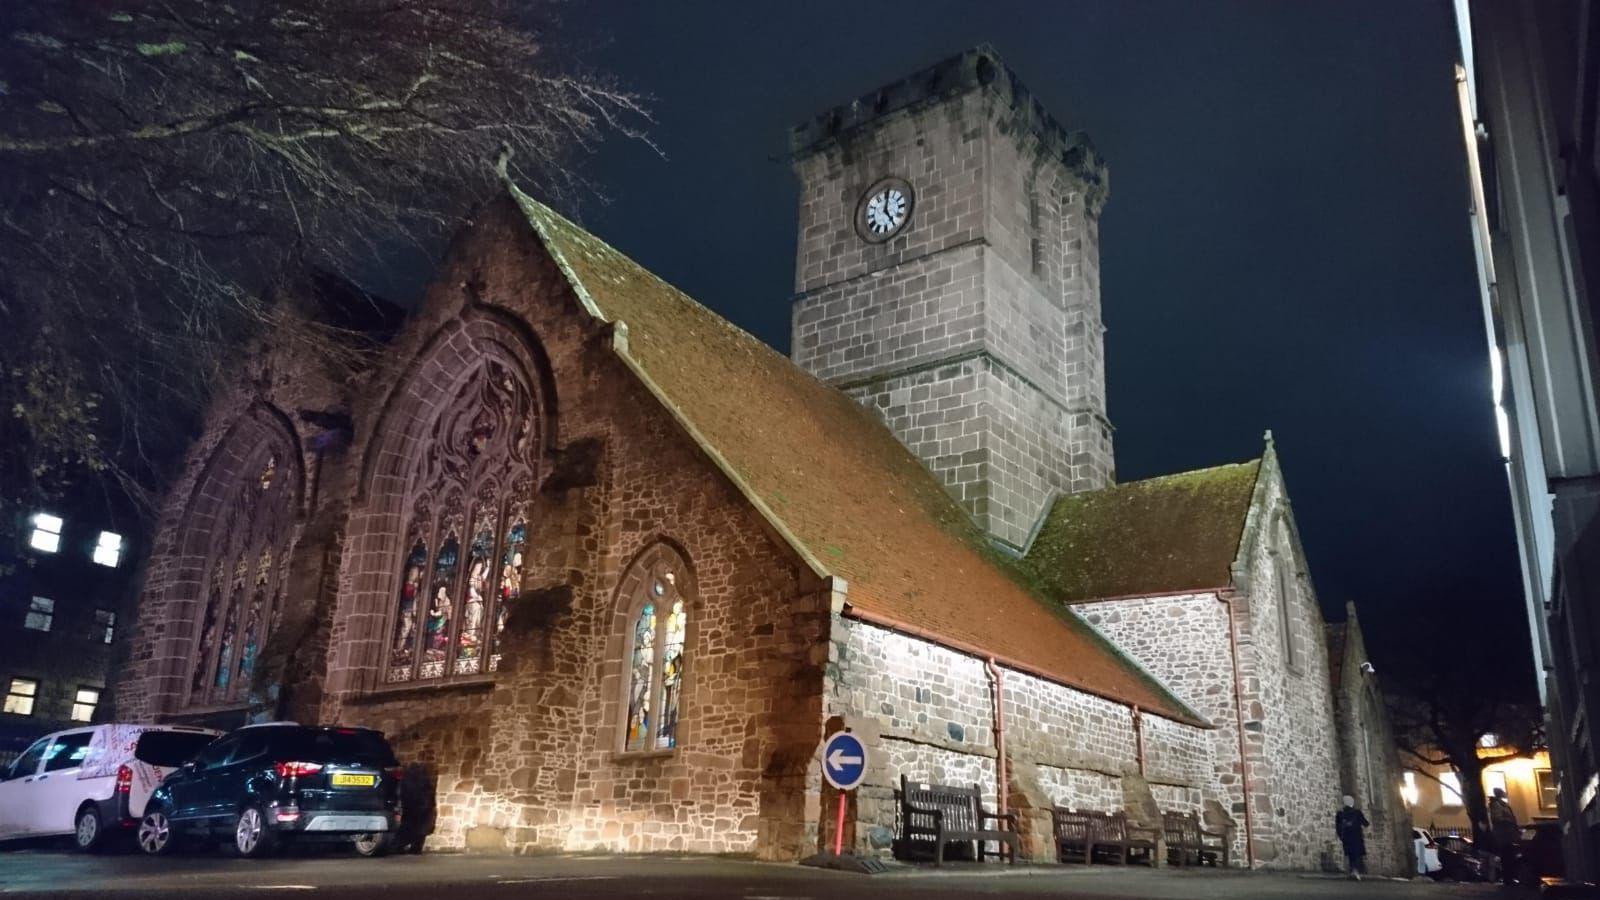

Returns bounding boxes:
[512,189,1206,724]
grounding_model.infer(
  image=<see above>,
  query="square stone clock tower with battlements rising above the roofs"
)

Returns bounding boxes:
[790,46,1114,549]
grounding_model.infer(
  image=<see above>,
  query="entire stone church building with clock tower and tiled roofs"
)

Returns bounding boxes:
[117,48,1401,868]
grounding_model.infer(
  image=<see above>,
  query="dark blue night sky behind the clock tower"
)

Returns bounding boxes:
[563,0,1531,685]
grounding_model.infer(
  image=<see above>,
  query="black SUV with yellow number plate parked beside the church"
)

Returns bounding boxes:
[138,724,403,857]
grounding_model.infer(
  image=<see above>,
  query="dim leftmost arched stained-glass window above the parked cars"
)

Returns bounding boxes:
[189,447,296,706]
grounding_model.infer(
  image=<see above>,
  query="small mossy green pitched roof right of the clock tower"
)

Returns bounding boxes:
[1027,460,1261,602]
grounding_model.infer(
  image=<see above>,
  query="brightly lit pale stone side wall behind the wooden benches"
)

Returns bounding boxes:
[824,617,1211,860]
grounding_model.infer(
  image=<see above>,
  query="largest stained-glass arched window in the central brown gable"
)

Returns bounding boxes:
[384,359,536,684]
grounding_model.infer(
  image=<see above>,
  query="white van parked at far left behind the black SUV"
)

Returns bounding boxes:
[0,725,221,850]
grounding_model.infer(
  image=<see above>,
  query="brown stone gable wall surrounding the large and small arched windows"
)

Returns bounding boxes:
[308,207,827,858]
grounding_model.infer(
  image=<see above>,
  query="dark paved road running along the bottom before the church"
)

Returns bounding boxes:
[0,847,1510,900]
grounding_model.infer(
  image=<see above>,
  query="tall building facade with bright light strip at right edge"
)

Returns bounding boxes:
[1456,0,1600,881]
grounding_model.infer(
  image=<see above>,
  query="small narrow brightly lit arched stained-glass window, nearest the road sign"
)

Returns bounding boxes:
[622,544,690,753]
